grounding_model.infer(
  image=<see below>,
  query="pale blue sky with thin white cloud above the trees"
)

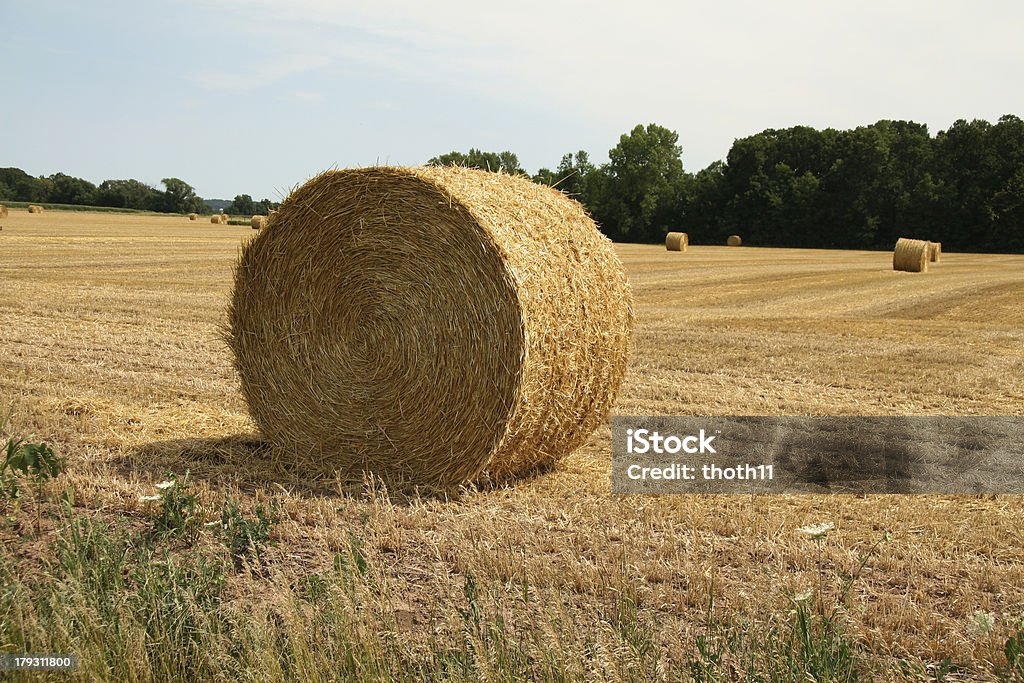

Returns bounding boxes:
[0,0,1024,201]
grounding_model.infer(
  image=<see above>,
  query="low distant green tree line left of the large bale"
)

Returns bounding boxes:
[0,168,279,215]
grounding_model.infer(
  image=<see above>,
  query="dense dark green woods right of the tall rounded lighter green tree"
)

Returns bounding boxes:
[680,116,1024,252]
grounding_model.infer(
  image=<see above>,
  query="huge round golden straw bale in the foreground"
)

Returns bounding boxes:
[229,167,633,485]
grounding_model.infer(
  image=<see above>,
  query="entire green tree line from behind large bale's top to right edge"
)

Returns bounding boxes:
[428,115,1024,253]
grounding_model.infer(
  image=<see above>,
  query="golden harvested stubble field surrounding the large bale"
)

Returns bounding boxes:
[0,210,1024,680]
